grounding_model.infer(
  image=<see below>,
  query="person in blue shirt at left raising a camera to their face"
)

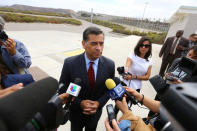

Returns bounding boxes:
[0,17,34,88]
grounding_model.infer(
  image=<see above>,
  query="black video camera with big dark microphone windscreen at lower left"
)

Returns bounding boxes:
[0,77,72,131]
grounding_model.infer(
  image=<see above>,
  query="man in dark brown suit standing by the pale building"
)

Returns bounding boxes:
[159,30,189,77]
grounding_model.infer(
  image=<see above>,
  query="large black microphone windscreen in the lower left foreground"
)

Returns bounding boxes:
[0,77,58,131]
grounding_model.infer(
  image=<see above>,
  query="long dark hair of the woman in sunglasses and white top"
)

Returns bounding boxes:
[134,37,152,61]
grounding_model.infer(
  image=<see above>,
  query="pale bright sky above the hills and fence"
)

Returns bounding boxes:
[0,0,197,19]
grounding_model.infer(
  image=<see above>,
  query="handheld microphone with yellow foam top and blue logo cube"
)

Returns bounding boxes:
[105,77,137,105]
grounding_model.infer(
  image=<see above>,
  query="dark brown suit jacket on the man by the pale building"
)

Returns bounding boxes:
[159,36,189,60]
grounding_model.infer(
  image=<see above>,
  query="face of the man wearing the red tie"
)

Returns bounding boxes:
[82,34,104,60]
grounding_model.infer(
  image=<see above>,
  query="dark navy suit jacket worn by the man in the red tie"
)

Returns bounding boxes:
[59,53,115,112]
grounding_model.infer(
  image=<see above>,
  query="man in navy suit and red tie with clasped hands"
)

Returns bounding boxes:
[59,27,115,131]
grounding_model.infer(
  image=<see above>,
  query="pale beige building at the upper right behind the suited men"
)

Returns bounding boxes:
[166,6,197,38]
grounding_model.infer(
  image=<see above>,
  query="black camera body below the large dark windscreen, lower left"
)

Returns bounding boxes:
[20,94,67,131]
